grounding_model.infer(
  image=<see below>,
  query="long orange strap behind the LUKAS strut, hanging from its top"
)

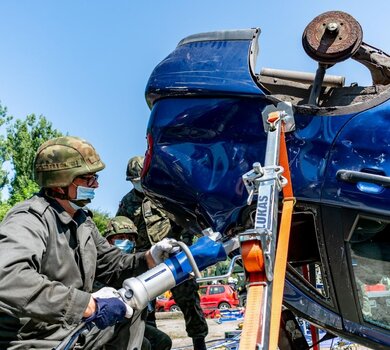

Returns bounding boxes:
[269,126,295,350]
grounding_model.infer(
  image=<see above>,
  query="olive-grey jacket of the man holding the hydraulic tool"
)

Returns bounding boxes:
[0,197,147,338]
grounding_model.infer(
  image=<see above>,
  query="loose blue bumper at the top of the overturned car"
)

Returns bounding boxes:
[146,29,264,105]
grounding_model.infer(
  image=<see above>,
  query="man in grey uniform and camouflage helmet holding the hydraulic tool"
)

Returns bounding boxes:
[0,136,173,350]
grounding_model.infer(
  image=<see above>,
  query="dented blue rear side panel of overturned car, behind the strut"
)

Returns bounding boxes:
[144,97,362,232]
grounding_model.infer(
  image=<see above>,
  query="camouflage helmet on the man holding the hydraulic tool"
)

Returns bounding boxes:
[34,136,105,187]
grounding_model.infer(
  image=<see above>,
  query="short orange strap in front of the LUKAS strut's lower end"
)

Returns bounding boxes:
[240,241,265,350]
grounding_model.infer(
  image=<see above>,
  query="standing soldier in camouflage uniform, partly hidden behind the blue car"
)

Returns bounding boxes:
[116,157,208,350]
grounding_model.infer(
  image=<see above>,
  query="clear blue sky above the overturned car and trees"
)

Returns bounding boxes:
[0,0,390,215]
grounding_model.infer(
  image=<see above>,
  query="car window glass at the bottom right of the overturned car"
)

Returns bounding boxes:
[350,218,390,329]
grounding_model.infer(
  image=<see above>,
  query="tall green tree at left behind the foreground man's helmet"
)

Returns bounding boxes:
[0,104,62,220]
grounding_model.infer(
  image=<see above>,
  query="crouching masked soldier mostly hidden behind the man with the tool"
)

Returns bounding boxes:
[103,216,172,350]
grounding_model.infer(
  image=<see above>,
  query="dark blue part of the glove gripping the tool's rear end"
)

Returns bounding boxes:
[85,297,126,329]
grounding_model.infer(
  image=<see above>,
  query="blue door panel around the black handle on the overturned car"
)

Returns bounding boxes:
[322,101,390,215]
